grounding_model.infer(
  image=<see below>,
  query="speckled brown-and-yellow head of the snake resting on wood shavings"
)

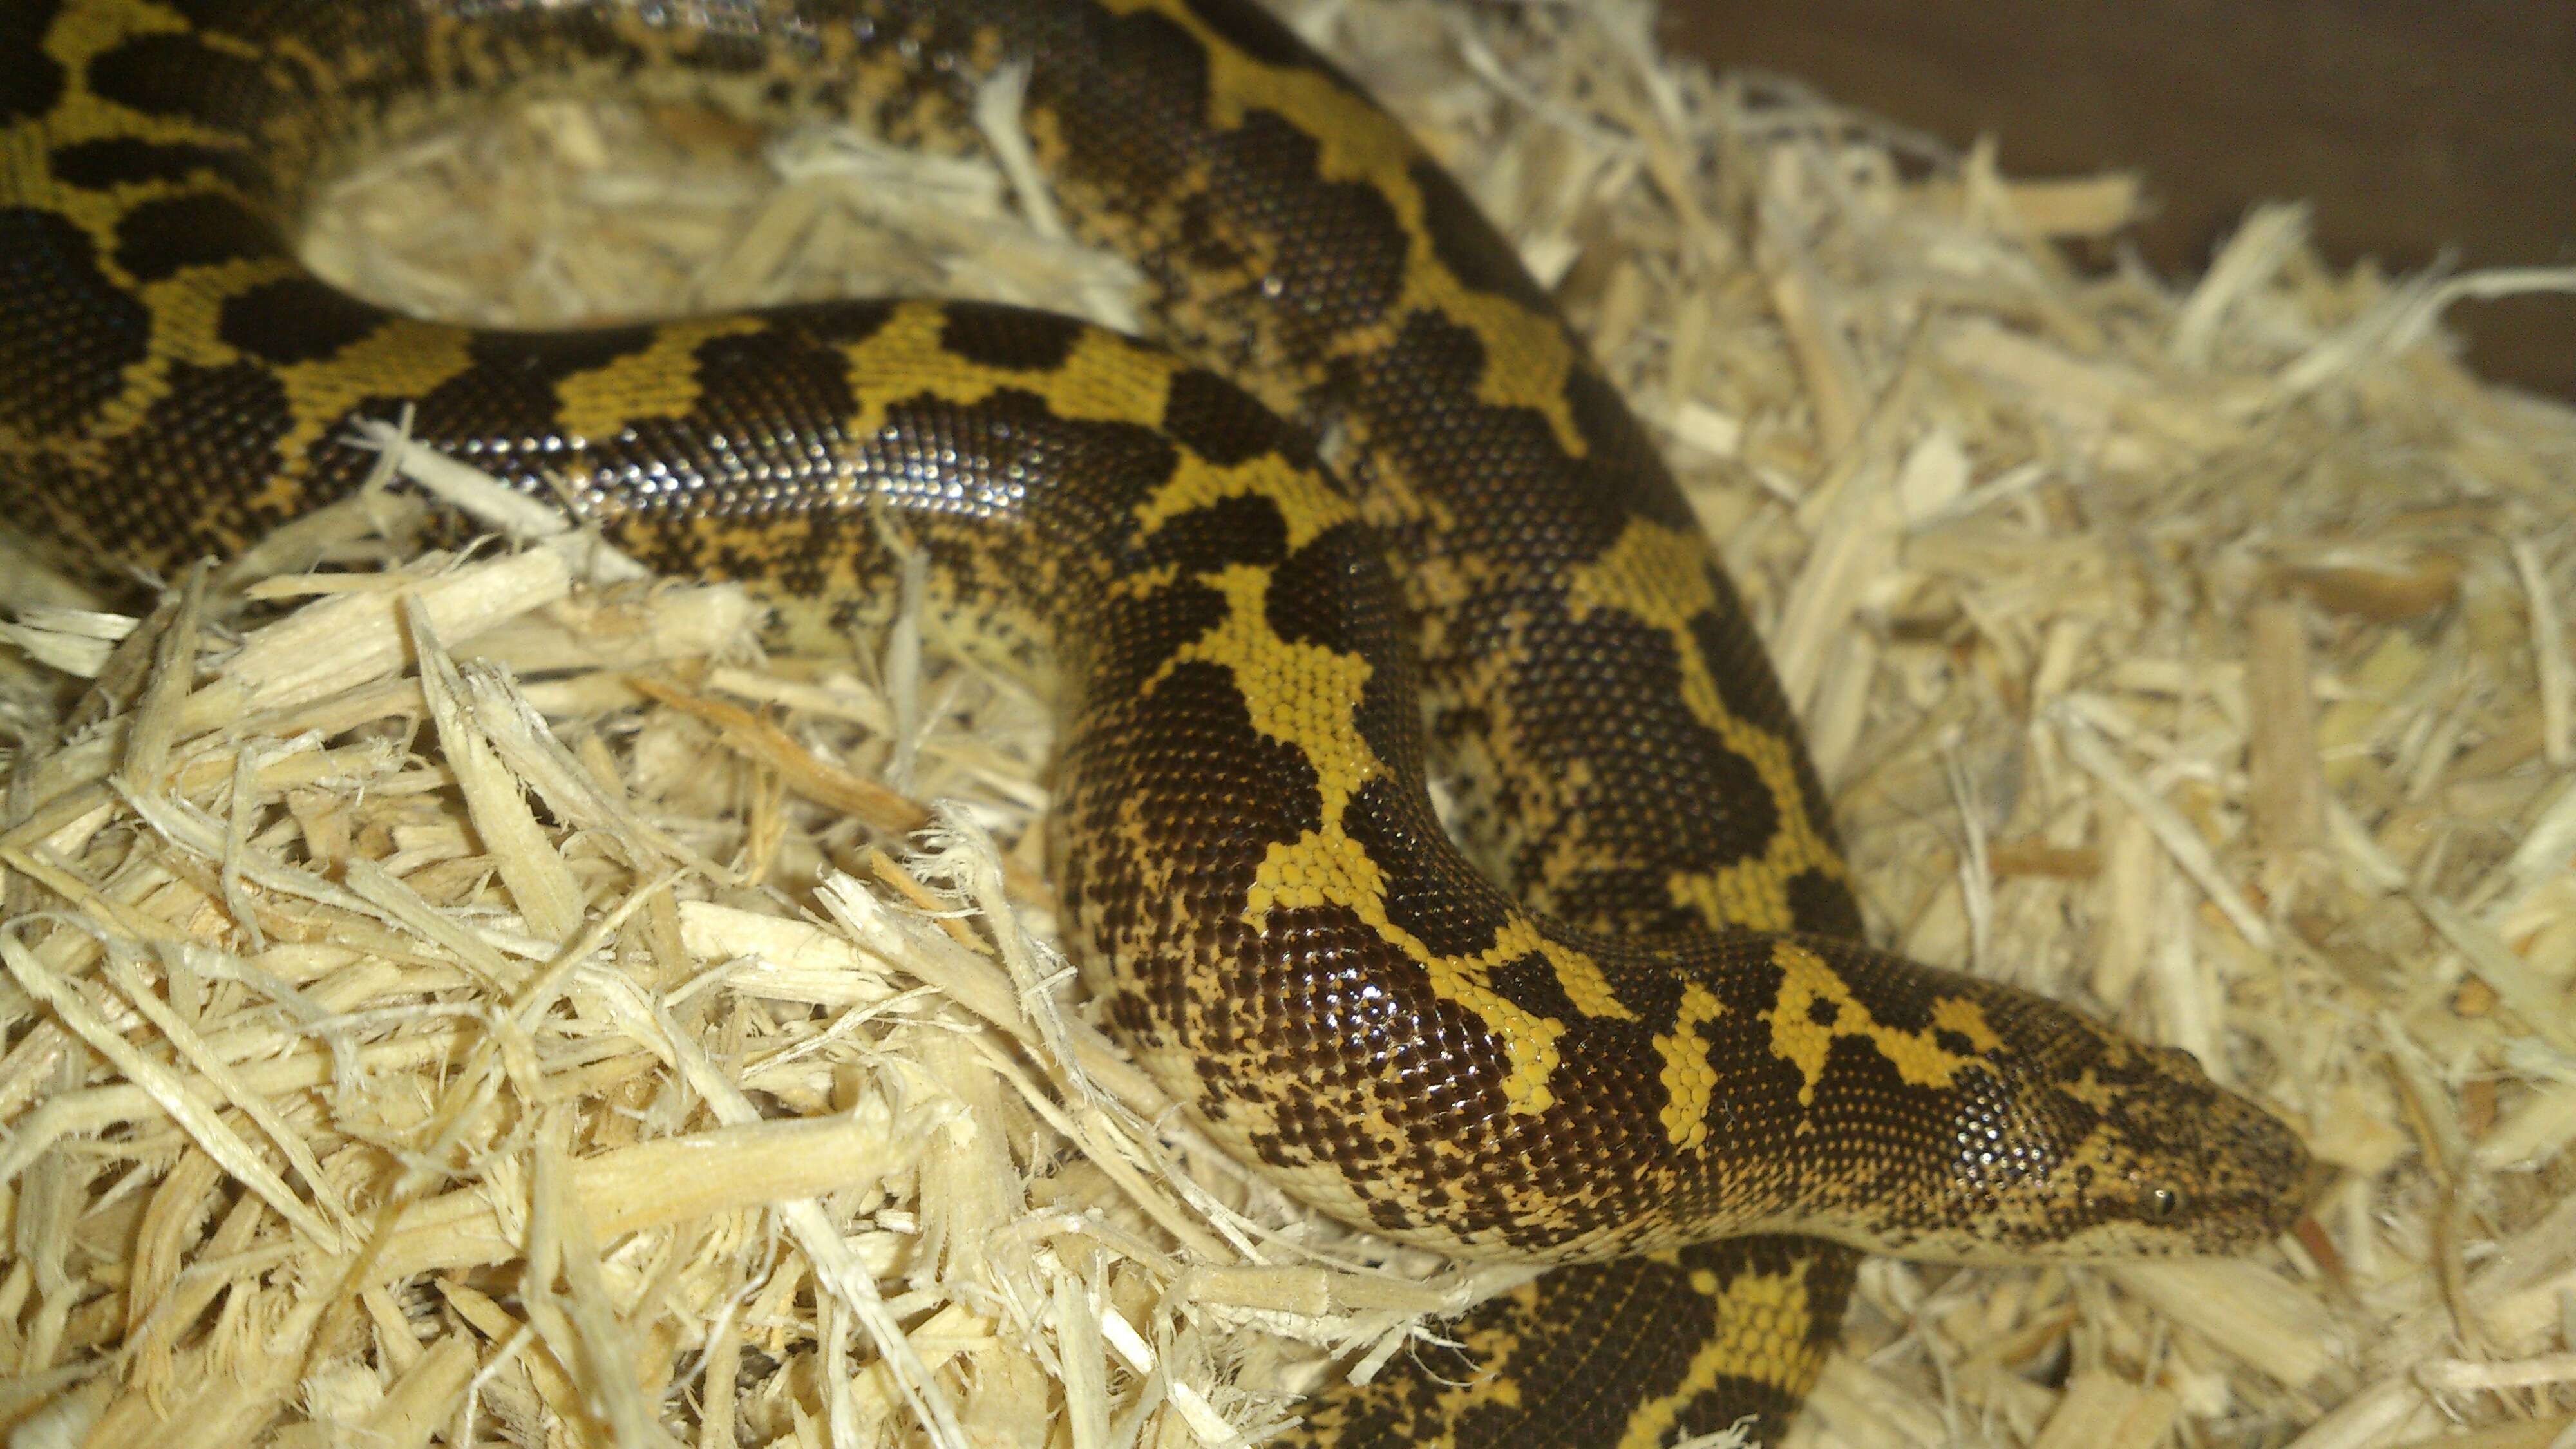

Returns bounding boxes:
[1772,941,2313,1264]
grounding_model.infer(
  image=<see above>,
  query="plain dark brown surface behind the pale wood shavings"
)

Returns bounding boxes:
[1664,0,2576,397]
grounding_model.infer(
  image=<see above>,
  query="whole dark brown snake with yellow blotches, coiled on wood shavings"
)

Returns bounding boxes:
[0,0,2306,1446]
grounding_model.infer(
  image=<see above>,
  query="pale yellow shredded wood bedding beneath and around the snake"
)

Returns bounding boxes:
[0,0,2576,1449]
